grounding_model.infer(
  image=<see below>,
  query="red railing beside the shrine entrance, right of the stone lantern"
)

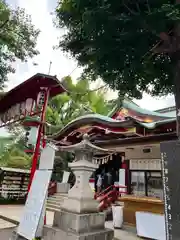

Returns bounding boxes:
[95,185,127,211]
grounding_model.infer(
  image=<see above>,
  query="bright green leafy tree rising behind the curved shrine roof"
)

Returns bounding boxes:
[46,76,112,132]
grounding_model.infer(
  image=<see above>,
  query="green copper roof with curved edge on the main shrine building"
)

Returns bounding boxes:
[50,99,176,141]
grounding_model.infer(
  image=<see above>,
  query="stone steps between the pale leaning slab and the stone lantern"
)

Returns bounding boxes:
[46,193,68,212]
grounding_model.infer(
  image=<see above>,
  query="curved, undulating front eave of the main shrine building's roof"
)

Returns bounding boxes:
[49,114,175,144]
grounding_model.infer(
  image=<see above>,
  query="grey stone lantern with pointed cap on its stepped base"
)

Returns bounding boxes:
[43,134,114,240]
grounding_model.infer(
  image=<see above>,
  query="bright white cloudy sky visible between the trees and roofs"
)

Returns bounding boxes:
[4,0,174,110]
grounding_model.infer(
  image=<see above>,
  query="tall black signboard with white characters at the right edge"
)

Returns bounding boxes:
[160,141,180,240]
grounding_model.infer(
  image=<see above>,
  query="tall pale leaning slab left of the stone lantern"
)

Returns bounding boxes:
[10,144,56,240]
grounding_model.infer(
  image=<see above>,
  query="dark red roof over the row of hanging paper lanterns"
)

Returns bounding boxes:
[0,73,66,113]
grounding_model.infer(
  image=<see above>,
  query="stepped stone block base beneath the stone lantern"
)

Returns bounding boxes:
[43,211,114,240]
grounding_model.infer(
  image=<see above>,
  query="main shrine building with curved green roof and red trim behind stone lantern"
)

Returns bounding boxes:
[53,100,176,199]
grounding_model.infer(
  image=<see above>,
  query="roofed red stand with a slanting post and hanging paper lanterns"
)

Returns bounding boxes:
[0,73,66,191]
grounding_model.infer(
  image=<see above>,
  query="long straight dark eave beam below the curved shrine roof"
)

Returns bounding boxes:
[93,132,177,147]
